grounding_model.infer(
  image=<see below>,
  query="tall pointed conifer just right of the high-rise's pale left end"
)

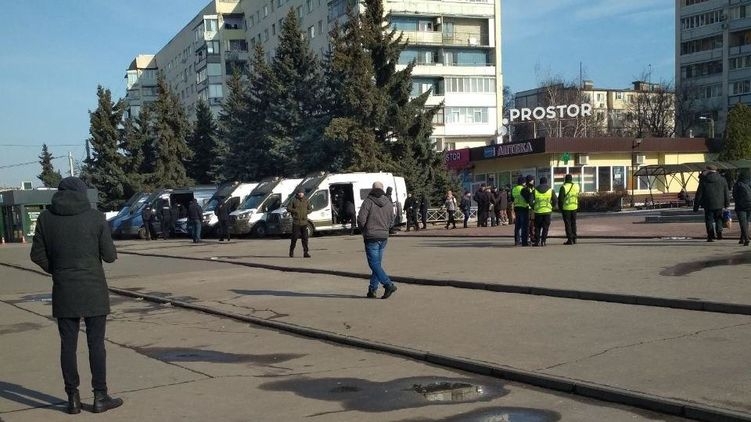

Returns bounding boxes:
[153,74,193,187]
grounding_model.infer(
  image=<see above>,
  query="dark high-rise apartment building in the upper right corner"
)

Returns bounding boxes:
[675,0,751,137]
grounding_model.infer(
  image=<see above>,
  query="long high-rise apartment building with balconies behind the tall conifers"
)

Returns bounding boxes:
[126,0,503,150]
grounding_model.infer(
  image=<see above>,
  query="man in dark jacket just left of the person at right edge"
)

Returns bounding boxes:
[694,165,730,242]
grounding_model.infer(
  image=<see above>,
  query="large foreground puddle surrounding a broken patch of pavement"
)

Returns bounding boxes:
[260,377,512,412]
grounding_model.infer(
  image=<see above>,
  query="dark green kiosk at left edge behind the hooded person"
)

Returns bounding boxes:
[0,189,98,242]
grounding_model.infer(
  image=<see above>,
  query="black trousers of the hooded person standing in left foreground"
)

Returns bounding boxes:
[57,315,107,393]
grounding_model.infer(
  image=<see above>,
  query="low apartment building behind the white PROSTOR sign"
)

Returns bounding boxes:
[510,81,675,140]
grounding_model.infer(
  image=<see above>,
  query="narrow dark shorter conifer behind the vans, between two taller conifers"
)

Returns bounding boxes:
[185,100,217,185]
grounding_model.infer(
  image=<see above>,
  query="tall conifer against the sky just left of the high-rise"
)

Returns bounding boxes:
[84,85,126,209]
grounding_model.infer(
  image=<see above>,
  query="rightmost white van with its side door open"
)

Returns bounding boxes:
[268,173,407,235]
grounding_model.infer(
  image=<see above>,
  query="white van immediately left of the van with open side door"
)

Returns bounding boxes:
[230,177,303,237]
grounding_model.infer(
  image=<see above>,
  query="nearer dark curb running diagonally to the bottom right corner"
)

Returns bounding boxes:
[109,288,751,422]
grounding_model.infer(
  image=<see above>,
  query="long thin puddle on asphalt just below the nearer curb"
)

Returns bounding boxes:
[134,347,306,365]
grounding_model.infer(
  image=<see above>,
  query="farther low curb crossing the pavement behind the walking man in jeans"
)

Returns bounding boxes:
[119,251,751,315]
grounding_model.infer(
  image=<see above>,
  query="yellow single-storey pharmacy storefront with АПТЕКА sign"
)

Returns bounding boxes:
[444,138,710,194]
